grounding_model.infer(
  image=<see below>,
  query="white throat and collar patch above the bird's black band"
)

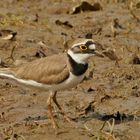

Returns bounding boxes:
[68,49,93,64]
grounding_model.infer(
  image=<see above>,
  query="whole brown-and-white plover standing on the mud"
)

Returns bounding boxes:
[0,39,102,128]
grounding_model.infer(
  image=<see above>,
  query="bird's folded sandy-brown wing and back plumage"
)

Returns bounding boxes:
[12,54,69,84]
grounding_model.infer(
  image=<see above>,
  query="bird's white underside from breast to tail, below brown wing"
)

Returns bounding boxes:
[0,73,84,91]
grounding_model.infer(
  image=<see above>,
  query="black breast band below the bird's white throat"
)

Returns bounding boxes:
[68,54,88,76]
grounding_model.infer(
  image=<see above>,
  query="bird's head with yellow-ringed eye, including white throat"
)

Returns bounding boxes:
[68,39,103,63]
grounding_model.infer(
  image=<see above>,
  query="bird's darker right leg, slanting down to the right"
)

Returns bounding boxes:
[52,91,71,122]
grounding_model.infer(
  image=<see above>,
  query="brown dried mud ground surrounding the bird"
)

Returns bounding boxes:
[0,0,140,140]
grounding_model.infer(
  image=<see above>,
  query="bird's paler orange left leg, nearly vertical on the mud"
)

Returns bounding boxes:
[47,92,58,129]
